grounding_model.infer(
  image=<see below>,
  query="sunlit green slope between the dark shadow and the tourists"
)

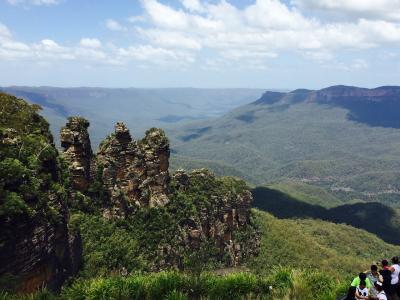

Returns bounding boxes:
[249,210,400,277]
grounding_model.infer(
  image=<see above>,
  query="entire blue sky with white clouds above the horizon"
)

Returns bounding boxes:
[0,0,400,89]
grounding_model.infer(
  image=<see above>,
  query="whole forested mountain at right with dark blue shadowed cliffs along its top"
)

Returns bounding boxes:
[169,86,400,206]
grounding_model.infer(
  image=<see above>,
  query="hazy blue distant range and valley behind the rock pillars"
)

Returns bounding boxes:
[0,87,265,147]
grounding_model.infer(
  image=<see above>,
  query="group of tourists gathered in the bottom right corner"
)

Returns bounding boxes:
[345,256,400,300]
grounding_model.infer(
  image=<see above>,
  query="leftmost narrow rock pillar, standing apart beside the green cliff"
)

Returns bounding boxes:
[60,117,93,192]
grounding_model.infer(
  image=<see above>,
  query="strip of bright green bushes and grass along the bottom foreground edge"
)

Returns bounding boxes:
[0,267,344,300]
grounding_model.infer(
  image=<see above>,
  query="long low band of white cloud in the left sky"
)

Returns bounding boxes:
[0,23,195,67]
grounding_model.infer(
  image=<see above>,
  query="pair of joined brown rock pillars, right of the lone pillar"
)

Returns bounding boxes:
[96,123,170,216]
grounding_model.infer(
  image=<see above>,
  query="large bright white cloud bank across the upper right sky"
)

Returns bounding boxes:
[133,0,400,64]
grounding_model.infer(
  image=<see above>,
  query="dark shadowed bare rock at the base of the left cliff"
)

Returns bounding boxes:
[0,202,82,293]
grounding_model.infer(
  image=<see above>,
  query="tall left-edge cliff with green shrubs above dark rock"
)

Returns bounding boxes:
[0,93,82,292]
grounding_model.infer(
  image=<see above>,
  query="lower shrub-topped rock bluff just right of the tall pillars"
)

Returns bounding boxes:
[169,169,260,266]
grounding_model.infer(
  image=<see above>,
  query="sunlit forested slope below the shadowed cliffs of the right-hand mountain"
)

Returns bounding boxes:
[170,103,400,205]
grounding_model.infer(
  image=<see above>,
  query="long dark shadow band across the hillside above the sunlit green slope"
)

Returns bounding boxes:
[252,187,400,247]
